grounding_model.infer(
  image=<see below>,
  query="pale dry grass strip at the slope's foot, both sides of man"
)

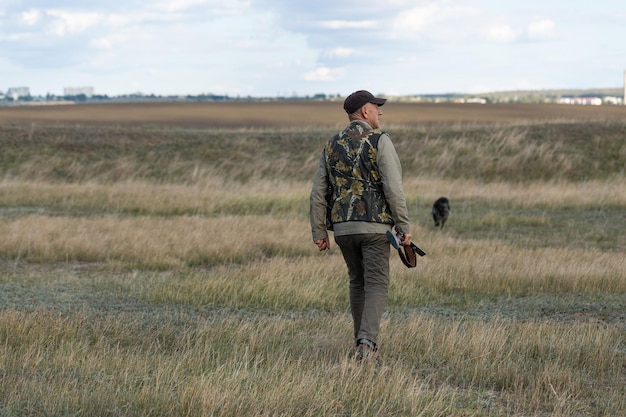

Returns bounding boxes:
[0,176,626,216]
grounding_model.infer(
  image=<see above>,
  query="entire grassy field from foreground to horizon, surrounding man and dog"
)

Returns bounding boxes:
[0,103,626,417]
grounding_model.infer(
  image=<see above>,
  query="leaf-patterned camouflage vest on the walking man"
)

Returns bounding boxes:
[325,123,394,224]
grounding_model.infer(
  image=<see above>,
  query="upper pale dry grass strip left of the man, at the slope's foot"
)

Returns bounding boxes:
[0,180,310,216]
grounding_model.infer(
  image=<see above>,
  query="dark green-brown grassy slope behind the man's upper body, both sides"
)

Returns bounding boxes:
[0,118,626,183]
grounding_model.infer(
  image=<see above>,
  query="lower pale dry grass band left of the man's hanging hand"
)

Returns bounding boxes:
[0,215,309,268]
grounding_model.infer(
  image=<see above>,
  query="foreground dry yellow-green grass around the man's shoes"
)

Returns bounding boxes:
[0,296,626,416]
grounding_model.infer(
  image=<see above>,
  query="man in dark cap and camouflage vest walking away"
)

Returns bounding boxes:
[309,90,411,364]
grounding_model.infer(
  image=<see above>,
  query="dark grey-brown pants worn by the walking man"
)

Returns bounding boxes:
[335,234,390,344]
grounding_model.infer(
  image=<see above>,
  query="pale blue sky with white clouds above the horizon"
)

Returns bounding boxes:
[0,0,626,97]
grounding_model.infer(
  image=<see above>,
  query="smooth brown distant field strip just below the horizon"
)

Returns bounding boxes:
[0,100,626,129]
